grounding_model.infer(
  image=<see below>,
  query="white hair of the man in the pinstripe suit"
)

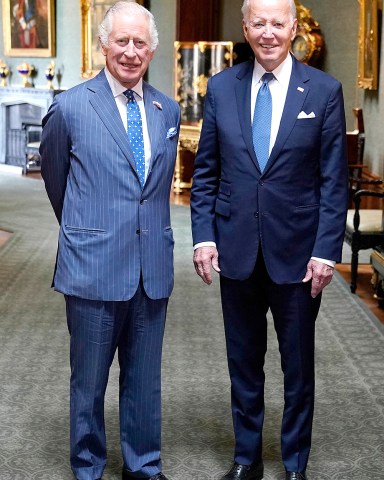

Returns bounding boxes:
[99,0,159,52]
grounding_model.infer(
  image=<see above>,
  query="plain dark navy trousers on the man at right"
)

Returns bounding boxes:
[220,254,321,471]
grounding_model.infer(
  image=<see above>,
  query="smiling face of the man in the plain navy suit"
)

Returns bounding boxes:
[243,0,297,72]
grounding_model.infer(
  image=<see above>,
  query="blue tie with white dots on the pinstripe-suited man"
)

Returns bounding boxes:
[124,90,145,187]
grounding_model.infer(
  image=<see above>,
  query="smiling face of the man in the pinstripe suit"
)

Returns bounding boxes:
[101,12,155,88]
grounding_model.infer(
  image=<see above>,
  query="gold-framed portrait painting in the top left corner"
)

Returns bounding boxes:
[2,0,55,58]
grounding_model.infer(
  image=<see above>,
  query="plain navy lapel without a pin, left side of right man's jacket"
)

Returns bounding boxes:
[235,61,259,169]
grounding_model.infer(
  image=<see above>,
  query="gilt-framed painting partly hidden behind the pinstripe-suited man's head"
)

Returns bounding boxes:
[80,0,148,78]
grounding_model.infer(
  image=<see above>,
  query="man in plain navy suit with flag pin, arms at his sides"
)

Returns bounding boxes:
[191,0,347,480]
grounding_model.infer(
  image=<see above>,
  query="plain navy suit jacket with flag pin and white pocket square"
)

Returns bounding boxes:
[191,58,348,284]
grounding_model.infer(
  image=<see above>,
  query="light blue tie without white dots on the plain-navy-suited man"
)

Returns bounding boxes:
[252,73,275,171]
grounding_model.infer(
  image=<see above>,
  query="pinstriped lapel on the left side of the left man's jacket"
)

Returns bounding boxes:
[88,70,136,172]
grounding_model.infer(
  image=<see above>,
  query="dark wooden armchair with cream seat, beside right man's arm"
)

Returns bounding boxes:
[344,187,384,293]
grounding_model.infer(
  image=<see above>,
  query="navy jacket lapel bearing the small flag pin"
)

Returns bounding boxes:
[264,58,309,172]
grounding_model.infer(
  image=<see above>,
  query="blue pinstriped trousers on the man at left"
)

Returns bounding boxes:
[65,282,168,480]
